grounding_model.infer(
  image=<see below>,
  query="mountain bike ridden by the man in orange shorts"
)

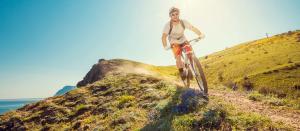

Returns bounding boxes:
[168,38,208,95]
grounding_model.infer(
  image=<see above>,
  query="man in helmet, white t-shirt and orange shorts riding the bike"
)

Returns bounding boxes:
[162,7,204,79]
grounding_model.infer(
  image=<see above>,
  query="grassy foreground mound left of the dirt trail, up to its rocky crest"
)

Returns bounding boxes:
[0,60,290,130]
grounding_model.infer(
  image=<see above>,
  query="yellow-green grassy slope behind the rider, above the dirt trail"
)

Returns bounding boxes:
[200,31,300,99]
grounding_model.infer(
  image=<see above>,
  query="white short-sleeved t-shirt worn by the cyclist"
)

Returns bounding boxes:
[163,20,193,44]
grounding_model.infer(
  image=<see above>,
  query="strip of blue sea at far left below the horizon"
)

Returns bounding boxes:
[0,98,42,114]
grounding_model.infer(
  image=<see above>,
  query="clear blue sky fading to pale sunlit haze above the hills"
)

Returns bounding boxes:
[0,0,300,99]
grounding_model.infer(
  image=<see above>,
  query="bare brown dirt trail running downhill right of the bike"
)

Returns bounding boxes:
[209,89,300,130]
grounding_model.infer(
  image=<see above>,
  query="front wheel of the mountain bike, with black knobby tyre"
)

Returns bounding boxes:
[193,56,208,94]
